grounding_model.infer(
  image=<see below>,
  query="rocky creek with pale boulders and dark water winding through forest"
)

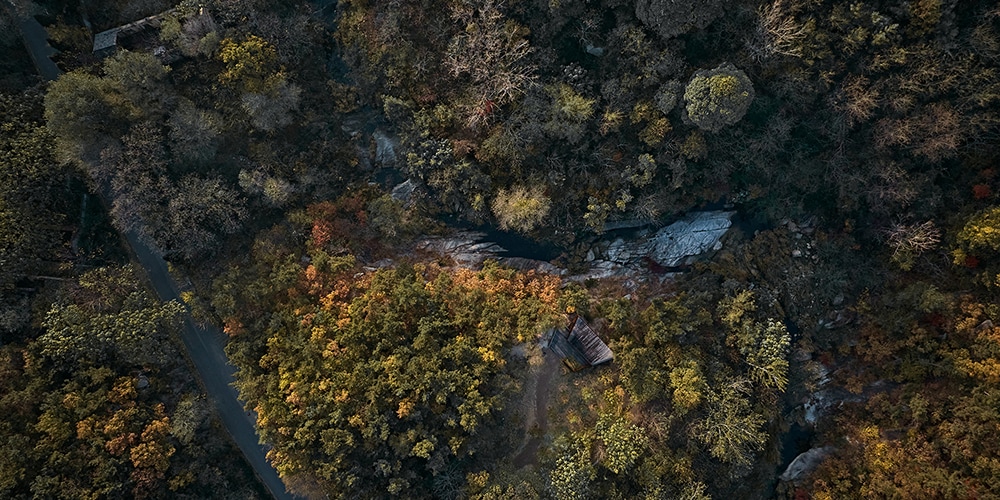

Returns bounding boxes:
[345,118,878,485]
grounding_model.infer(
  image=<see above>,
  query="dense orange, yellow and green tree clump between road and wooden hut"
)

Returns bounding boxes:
[224,254,557,496]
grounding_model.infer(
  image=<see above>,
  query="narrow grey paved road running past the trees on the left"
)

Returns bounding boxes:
[4,0,295,500]
